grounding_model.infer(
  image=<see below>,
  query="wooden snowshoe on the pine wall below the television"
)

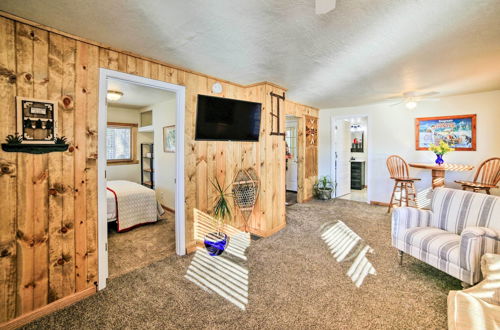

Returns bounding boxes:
[232,168,259,231]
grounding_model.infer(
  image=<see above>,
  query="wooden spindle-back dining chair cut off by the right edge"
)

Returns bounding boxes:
[455,157,500,195]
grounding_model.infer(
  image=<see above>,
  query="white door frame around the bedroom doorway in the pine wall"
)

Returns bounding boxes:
[97,68,186,290]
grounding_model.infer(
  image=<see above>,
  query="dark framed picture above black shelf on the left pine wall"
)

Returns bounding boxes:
[16,96,57,144]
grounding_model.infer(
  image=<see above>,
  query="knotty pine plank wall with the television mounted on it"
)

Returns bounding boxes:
[0,14,318,322]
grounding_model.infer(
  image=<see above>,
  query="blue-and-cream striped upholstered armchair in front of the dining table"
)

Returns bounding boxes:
[392,188,500,284]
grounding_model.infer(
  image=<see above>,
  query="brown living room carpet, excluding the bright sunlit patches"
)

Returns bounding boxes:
[27,200,460,329]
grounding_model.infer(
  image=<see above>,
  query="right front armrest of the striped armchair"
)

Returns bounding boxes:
[459,227,500,284]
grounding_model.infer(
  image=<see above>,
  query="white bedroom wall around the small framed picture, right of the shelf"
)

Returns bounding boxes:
[147,98,177,209]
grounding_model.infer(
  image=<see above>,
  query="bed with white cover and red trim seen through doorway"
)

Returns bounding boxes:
[106,180,164,232]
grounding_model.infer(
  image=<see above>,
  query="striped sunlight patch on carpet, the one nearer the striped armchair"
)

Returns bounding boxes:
[321,221,377,288]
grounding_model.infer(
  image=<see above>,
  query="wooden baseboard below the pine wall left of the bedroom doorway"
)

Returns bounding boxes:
[0,286,96,330]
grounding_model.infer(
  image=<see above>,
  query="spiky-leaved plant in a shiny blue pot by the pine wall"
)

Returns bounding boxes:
[204,179,231,256]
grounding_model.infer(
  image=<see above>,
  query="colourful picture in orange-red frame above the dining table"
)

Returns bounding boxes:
[415,115,476,151]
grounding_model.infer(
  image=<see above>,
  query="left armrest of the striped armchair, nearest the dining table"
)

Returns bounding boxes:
[392,207,432,242]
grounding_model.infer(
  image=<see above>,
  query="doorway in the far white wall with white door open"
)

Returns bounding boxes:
[331,115,369,202]
